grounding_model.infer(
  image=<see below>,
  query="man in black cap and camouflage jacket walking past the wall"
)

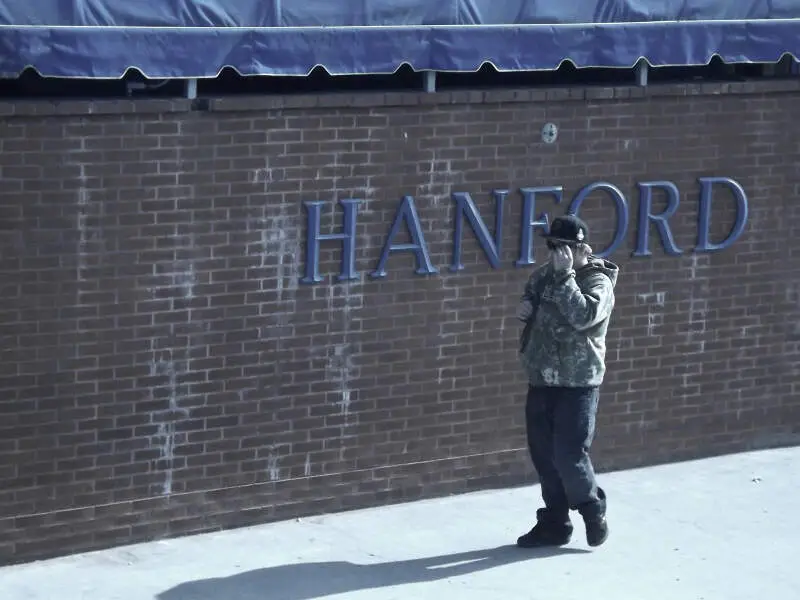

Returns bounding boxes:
[517,215,619,548]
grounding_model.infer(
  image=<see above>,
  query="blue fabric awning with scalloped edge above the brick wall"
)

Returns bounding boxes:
[0,0,800,79]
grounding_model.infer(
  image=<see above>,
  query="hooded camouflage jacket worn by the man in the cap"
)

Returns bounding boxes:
[520,257,619,387]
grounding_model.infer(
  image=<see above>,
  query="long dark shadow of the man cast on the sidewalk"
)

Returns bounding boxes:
[157,546,588,600]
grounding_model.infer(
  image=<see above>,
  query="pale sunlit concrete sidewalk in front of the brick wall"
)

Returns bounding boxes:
[0,448,800,600]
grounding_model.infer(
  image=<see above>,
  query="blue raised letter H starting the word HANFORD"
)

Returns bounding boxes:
[300,200,361,283]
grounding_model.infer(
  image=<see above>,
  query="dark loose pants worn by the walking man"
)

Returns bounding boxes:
[525,387,605,518]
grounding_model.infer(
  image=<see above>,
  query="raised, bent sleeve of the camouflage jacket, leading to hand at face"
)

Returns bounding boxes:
[552,271,614,331]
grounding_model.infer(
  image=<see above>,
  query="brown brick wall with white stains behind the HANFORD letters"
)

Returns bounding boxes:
[0,82,800,561]
